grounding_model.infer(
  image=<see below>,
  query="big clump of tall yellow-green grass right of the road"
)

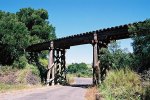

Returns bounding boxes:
[100,68,144,100]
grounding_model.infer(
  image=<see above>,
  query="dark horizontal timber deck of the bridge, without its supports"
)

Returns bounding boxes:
[26,22,143,52]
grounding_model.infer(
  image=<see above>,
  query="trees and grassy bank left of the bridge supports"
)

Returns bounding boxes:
[0,8,56,91]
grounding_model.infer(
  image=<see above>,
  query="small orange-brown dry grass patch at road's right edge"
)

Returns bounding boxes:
[85,87,103,100]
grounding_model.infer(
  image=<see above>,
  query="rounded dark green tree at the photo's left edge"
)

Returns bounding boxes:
[0,11,30,65]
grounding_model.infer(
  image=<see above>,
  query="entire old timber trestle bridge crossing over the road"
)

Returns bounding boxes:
[26,22,143,85]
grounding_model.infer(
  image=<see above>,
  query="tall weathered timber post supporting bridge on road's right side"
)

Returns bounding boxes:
[93,33,100,85]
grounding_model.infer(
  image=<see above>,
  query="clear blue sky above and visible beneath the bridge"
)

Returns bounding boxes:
[0,0,150,63]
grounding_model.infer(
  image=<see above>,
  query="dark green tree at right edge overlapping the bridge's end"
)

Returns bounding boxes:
[129,19,150,72]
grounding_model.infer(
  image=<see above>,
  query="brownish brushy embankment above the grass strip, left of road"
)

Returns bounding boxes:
[0,69,40,85]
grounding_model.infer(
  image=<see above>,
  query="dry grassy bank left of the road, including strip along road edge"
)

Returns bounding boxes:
[0,64,40,92]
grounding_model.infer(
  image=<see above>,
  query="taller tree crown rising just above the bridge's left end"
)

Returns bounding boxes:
[16,8,56,42]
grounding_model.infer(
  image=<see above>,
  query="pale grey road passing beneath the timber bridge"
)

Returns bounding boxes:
[0,78,92,100]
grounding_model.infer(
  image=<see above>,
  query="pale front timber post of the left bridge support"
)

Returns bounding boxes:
[47,41,55,86]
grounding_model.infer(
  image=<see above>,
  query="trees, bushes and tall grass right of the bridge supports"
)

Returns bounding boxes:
[99,20,150,100]
